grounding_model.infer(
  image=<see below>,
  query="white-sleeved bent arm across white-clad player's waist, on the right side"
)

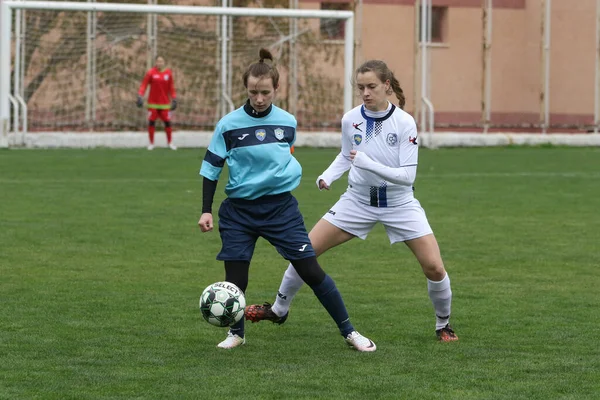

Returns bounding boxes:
[353,120,419,186]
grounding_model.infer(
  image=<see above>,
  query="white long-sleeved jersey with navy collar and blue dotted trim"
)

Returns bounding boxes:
[341,104,419,207]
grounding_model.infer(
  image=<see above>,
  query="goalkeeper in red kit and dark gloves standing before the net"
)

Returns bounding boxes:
[136,56,177,150]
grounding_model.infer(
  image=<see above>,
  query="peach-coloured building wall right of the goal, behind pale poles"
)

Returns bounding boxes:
[308,0,597,130]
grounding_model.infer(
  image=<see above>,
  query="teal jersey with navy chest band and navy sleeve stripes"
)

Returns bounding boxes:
[200,103,302,200]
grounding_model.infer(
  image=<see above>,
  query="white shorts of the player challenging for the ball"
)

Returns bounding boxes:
[323,193,433,244]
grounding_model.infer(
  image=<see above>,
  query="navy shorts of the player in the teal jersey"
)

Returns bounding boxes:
[217,192,315,261]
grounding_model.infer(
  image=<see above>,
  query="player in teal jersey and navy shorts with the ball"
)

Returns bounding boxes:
[198,49,377,352]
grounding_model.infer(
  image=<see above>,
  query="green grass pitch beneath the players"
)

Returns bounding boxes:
[0,147,600,400]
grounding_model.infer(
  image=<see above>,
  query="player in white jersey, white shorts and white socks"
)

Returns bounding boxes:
[245,60,458,342]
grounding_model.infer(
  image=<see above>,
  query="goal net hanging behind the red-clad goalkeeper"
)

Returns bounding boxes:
[0,0,352,141]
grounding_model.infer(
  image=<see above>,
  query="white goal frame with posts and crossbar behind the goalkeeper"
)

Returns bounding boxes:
[0,0,354,147]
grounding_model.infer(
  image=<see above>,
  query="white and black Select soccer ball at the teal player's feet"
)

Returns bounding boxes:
[200,282,246,327]
